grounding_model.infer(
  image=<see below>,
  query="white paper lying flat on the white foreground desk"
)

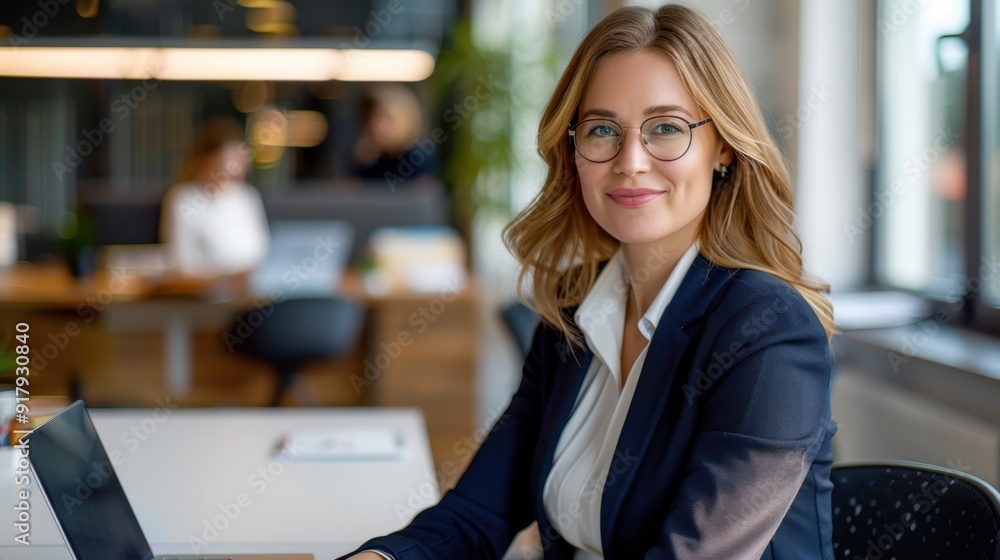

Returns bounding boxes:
[282,428,406,461]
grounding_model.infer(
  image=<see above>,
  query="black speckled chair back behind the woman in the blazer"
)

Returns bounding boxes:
[831,461,1000,560]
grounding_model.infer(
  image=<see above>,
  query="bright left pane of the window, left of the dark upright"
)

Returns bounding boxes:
[872,0,969,296]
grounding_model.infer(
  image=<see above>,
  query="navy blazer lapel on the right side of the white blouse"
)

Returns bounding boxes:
[601,254,731,558]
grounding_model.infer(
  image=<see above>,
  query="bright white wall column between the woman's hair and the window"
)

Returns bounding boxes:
[795,0,871,290]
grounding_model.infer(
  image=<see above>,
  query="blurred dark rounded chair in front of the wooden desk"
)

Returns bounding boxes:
[227,297,364,406]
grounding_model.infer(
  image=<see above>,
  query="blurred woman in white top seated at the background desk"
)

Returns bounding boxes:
[160,119,269,284]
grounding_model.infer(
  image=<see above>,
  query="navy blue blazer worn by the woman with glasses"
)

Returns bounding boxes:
[342,255,837,560]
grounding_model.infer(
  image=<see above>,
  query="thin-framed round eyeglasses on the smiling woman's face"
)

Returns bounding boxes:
[569,116,712,163]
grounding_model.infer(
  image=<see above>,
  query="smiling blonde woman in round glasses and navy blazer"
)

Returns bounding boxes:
[344,5,836,560]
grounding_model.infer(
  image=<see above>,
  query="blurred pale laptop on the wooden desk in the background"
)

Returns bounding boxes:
[250,220,354,299]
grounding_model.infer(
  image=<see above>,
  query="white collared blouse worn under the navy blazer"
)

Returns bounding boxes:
[543,241,699,560]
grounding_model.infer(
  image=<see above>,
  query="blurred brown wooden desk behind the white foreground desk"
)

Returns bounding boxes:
[0,264,478,488]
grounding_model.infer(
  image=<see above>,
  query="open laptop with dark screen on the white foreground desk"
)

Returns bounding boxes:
[28,401,314,560]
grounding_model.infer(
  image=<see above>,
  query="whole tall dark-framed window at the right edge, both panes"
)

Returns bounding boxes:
[872,0,1000,325]
